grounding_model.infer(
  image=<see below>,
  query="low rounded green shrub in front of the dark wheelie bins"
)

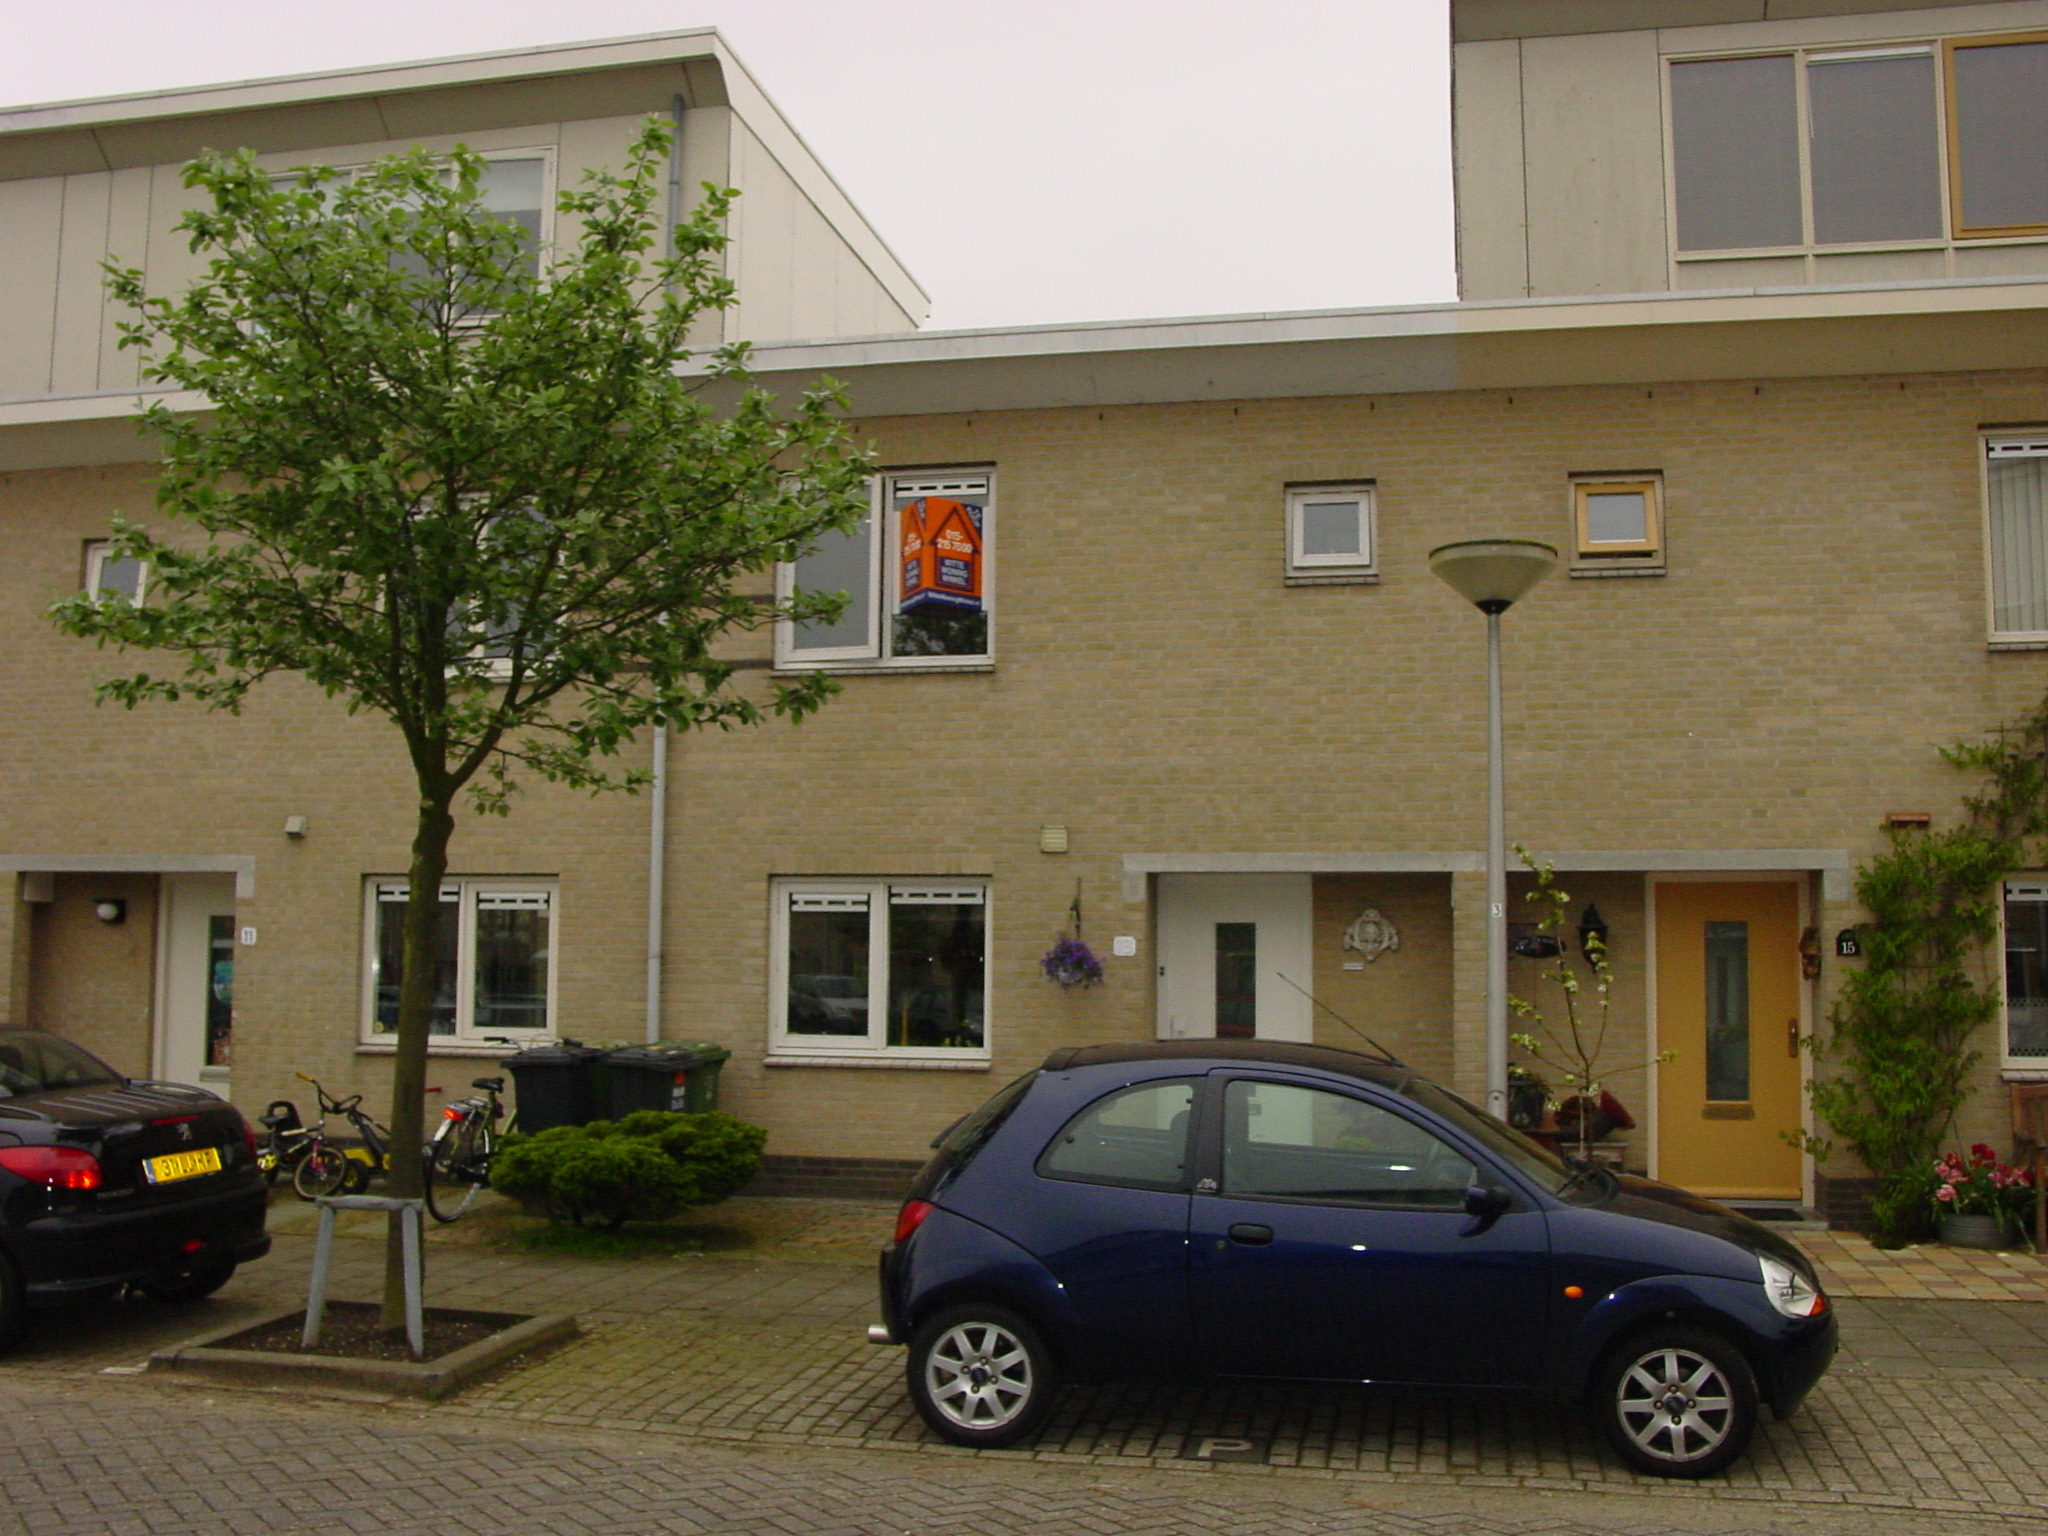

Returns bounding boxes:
[492,1110,768,1229]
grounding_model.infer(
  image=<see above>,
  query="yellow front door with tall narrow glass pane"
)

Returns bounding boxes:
[1657,881,1800,1200]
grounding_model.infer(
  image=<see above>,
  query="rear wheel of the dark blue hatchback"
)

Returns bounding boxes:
[905,1305,1059,1446]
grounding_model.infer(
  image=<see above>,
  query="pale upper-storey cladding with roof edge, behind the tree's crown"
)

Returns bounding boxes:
[0,29,928,401]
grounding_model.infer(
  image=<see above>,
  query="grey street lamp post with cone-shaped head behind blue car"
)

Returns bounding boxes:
[1430,539,1556,1120]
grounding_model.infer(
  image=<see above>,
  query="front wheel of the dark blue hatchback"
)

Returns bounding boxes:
[1591,1327,1757,1477]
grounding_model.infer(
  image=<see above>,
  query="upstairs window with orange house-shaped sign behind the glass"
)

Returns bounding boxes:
[776,469,995,668]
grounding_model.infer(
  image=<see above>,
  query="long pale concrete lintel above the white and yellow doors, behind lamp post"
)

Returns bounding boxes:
[1124,848,1853,903]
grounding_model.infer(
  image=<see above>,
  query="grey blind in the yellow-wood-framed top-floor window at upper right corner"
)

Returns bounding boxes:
[1954,43,2048,229]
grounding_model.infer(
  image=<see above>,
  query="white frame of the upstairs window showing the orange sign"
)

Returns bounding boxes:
[774,465,999,672]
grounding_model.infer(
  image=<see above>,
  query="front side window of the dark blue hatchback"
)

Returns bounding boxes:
[1223,1079,1477,1210]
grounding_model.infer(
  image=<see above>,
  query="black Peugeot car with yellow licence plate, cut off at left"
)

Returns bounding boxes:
[0,1028,270,1346]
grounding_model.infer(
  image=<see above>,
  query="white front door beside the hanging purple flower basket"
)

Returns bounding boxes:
[1159,874,1315,1040]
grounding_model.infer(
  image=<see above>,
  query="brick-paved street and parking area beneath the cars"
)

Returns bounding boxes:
[0,1206,2048,1536]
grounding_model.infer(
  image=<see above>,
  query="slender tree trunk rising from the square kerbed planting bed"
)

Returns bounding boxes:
[381,791,455,1331]
